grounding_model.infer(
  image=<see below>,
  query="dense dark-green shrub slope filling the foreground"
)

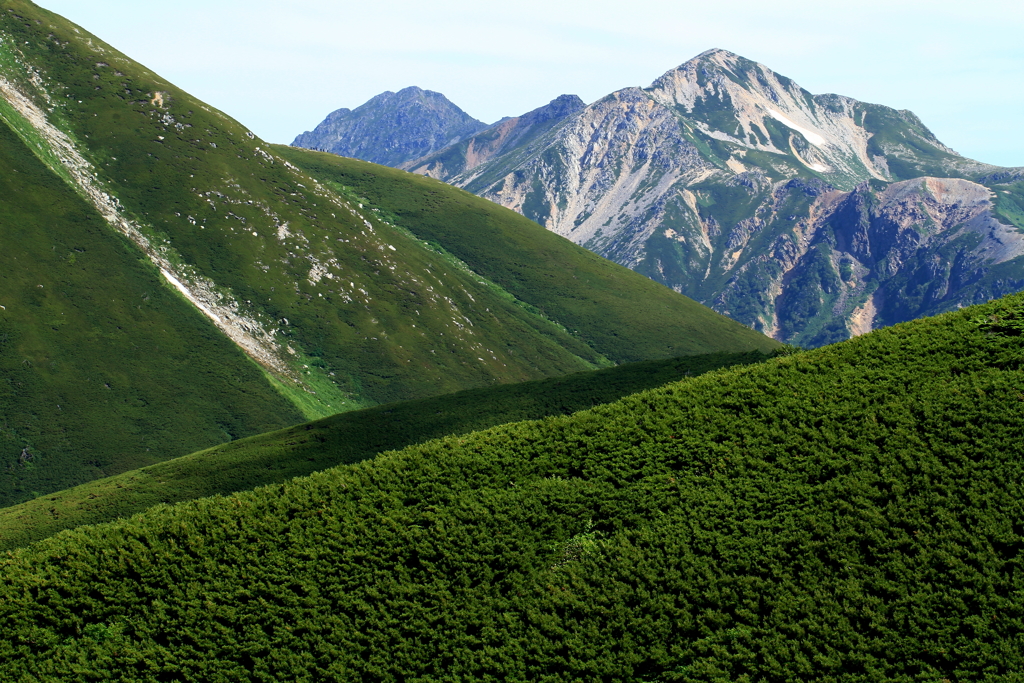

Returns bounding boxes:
[0,296,1024,682]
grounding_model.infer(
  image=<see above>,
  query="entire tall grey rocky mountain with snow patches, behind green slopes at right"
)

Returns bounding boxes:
[295,50,1024,346]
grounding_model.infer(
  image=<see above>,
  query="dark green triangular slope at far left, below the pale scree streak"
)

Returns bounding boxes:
[0,107,302,506]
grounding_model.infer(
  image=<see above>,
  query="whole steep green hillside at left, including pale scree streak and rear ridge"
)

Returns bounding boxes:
[0,0,777,504]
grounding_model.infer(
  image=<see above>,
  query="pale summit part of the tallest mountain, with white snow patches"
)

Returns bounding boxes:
[646,49,970,189]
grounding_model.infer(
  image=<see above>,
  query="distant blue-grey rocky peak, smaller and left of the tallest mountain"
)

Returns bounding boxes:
[292,86,487,166]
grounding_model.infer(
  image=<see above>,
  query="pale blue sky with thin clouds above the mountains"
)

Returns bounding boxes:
[40,0,1024,166]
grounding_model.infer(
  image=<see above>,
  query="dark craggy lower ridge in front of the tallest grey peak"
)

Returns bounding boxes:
[696,176,1024,346]
